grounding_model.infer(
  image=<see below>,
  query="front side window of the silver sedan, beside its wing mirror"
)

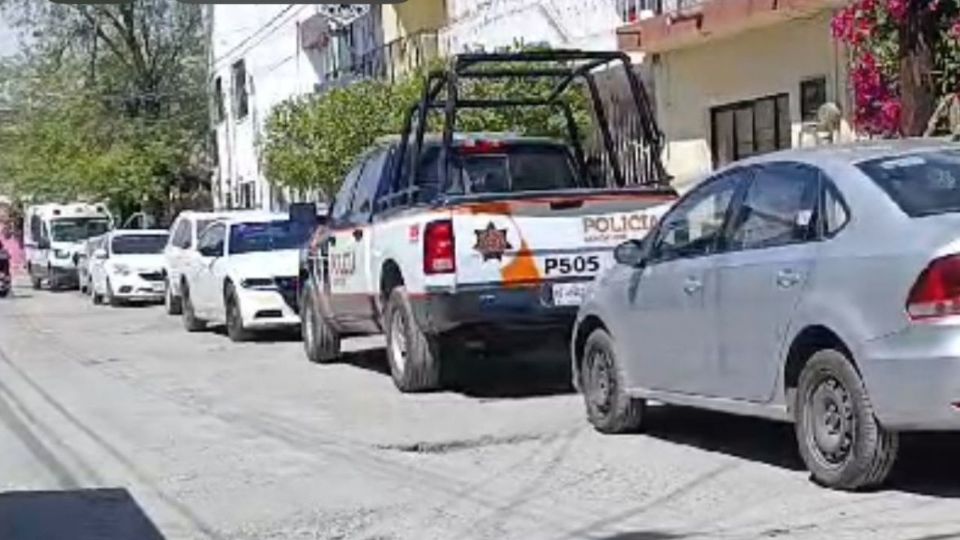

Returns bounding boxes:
[653,172,742,260]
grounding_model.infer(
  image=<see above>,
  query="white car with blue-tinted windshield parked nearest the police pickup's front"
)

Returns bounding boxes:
[179,212,312,341]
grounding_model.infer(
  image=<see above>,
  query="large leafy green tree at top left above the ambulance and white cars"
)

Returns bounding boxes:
[0,0,208,219]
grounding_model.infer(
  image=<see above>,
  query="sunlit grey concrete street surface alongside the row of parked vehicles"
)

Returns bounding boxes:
[0,282,960,540]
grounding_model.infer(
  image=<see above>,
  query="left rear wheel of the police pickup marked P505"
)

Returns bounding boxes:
[384,287,440,393]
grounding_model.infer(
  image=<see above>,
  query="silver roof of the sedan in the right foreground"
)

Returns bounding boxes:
[731,137,960,166]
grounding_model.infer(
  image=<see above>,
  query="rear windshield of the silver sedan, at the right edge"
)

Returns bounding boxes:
[858,150,960,217]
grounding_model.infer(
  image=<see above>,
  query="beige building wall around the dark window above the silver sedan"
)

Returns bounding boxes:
[654,11,850,189]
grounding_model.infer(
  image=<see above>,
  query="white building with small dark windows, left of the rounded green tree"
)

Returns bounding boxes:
[209,4,380,210]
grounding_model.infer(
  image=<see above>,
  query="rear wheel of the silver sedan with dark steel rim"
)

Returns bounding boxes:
[795,349,899,490]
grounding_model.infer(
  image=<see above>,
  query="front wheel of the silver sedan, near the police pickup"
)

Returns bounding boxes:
[580,328,646,433]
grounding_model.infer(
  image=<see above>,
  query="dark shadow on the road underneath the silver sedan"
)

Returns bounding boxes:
[644,404,960,498]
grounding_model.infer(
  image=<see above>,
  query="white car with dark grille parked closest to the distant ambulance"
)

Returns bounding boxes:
[89,229,167,306]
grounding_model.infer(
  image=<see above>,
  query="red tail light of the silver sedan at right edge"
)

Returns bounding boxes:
[907,255,960,320]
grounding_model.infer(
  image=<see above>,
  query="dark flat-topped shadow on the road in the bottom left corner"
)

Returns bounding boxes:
[0,488,164,540]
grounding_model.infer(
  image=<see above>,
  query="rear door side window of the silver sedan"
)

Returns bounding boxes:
[727,164,819,250]
